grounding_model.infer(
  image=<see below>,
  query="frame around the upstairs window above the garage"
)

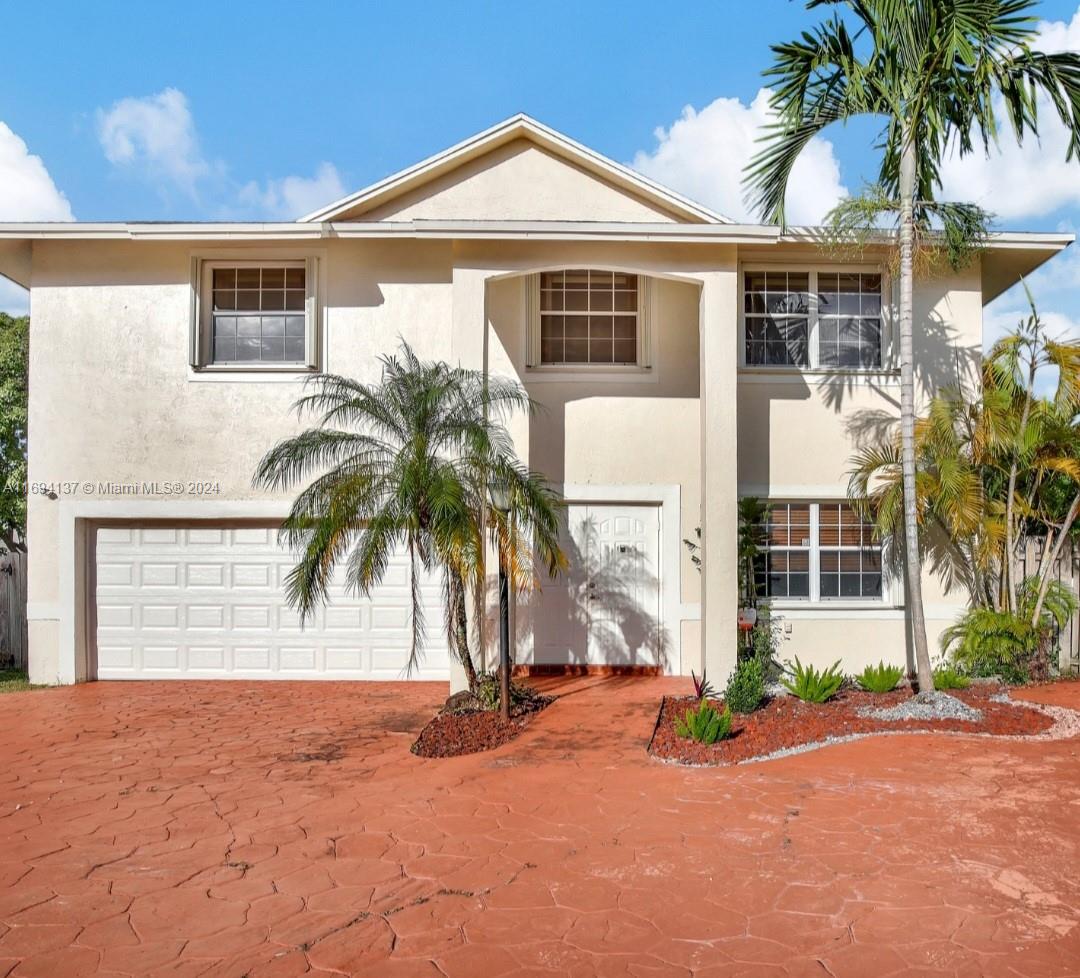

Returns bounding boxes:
[189,254,321,375]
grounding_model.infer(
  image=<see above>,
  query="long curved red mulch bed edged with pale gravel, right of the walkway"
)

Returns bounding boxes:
[649,682,1054,764]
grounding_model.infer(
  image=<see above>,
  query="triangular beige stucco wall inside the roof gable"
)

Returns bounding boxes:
[362,139,675,221]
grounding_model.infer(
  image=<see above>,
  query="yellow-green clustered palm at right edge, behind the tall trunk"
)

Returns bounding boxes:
[849,295,1080,647]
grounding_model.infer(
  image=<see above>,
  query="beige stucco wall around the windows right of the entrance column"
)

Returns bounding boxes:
[739,253,982,671]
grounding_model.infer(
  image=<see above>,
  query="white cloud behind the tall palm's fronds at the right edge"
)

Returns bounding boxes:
[942,9,1080,220]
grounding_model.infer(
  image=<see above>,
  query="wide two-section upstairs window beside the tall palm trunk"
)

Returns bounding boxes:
[743,270,885,369]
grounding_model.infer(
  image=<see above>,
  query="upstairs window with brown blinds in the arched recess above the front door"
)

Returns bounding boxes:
[529,269,645,367]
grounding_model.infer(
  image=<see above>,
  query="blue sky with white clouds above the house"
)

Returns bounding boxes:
[0,0,1080,335]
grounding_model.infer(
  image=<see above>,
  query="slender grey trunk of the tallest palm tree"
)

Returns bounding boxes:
[900,133,934,692]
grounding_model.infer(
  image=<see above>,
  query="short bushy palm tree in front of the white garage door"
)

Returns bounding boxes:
[253,341,565,689]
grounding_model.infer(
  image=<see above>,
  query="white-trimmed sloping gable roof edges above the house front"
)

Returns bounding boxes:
[299,113,731,225]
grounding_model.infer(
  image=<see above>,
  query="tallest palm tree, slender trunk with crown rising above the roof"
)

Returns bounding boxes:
[747,0,1080,690]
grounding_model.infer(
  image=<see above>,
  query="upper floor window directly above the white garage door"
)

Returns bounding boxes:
[194,260,315,370]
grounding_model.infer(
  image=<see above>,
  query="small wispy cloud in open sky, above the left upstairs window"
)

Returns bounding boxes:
[97,89,214,198]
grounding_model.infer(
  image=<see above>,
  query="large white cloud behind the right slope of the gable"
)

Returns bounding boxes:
[632,89,848,225]
